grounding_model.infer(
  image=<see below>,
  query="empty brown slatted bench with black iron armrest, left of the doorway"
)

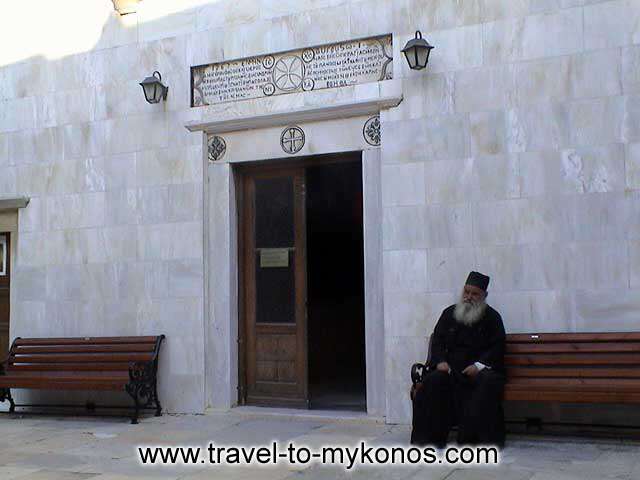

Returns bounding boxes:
[0,335,164,423]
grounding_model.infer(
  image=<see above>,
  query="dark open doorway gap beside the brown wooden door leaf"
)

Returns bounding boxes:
[306,158,366,411]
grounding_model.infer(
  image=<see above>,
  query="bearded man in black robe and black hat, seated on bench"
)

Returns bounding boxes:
[411,272,505,448]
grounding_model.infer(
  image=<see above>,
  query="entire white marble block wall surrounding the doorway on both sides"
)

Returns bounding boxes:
[0,0,640,422]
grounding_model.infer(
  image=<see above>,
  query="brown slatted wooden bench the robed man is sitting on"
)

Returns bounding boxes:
[411,332,640,432]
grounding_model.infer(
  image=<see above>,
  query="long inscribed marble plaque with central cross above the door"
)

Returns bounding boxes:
[191,35,393,107]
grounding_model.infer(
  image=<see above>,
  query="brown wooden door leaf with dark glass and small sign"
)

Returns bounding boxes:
[242,169,308,406]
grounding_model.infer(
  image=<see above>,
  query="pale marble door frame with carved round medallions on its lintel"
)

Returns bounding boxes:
[186,95,402,417]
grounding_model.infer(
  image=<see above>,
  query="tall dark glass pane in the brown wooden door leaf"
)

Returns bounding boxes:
[255,177,296,323]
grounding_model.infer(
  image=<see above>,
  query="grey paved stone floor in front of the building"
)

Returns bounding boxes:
[0,411,640,480]
